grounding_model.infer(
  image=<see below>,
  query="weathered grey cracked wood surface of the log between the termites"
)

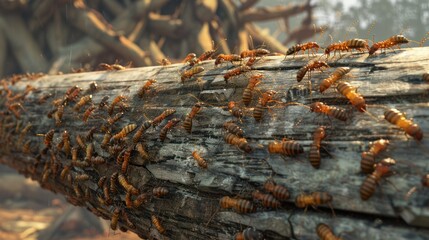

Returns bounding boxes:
[0,48,429,239]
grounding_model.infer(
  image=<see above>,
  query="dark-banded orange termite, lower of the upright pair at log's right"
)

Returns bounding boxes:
[360,158,395,201]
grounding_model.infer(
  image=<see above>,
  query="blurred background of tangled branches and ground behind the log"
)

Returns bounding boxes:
[0,0,429,240]
